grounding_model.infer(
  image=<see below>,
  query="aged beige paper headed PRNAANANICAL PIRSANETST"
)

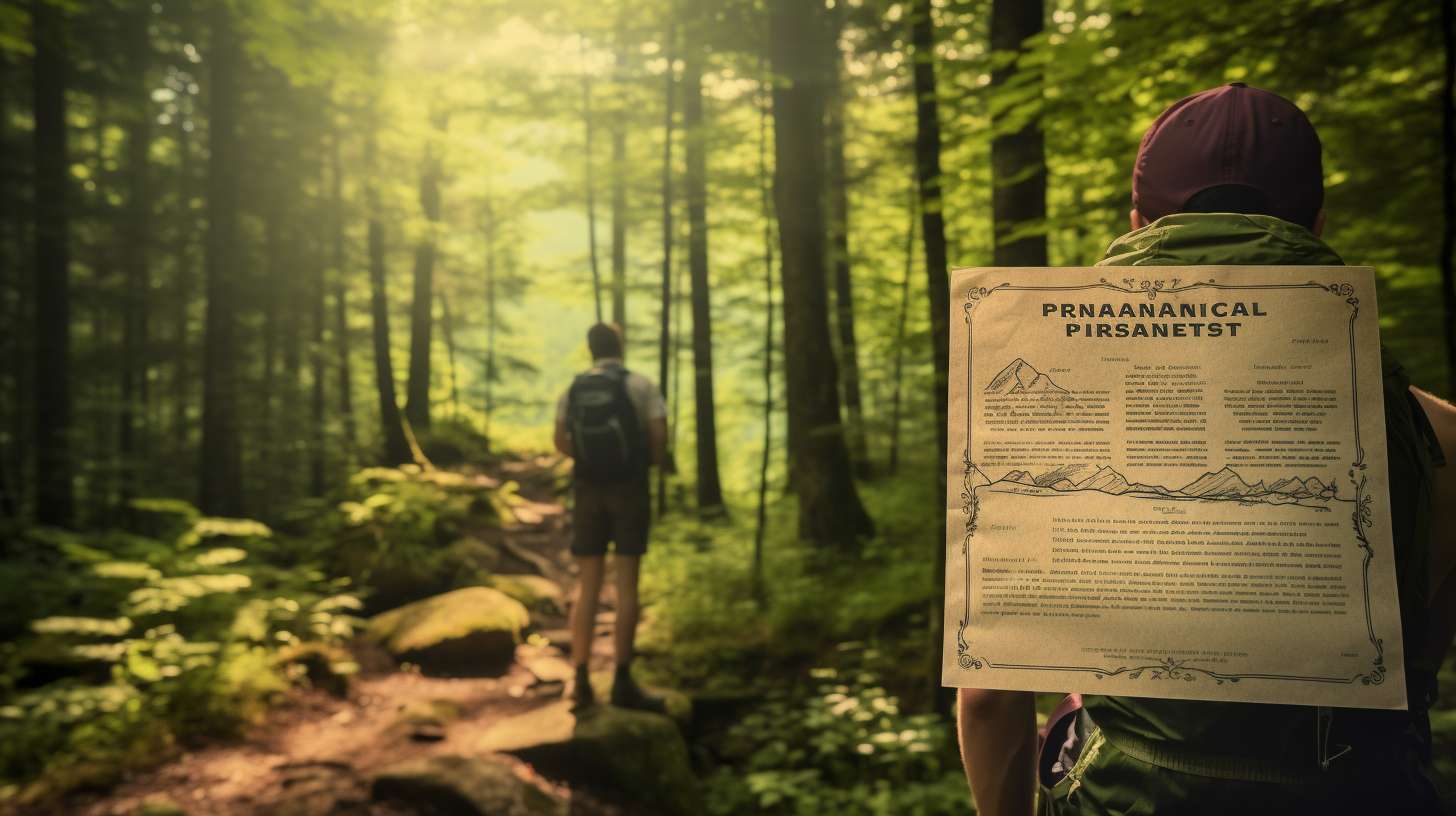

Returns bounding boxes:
[942,267,1405,708]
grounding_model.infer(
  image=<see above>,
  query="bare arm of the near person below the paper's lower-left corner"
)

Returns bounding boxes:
[957,689,1037,816]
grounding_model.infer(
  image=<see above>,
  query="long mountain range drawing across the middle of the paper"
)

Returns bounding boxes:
[973,465,1335,504]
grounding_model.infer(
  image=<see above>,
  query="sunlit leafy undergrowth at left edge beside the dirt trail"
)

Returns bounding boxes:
[0,507,360,790]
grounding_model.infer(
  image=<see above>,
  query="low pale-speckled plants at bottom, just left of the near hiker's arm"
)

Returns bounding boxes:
[708,667,967,816]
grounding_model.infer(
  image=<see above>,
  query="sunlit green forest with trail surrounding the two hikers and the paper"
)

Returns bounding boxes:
[0,0,1456,816]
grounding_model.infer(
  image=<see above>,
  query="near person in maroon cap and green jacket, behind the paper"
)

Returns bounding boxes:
[957,83,1456,816]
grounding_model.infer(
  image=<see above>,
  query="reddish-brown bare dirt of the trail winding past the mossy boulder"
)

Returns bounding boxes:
[57,459,634,816]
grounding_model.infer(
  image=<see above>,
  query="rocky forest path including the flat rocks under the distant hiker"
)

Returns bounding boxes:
[61,459,696,816]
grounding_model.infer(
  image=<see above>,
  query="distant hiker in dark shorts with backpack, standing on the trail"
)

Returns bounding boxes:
[556,323,667,710]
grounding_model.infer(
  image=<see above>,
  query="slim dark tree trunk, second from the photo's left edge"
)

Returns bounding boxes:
[116,6,151,503]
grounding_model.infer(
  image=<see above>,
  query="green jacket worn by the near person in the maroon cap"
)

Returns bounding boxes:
[1048,213,1430,813]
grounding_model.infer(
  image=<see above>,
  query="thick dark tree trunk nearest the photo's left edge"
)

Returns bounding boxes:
[31,0,76,526]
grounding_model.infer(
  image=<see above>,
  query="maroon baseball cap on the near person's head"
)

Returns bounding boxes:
[1133,82,1325,226]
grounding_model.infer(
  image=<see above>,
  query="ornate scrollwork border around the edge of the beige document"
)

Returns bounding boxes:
[955,278,1386,685]
